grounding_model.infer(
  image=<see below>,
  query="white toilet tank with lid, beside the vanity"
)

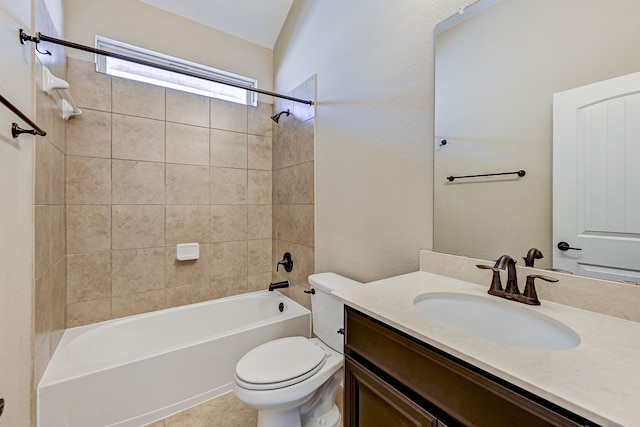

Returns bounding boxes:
[309,273,362,353]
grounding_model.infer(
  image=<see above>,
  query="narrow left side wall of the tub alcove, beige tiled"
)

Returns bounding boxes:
[32,1,67,412]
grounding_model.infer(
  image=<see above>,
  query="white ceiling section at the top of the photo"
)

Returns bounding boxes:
[140,0,293,49]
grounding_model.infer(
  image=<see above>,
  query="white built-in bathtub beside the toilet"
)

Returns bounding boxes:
[37,291,311,427]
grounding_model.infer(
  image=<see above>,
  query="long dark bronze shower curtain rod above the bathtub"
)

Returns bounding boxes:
[20,29,313,105]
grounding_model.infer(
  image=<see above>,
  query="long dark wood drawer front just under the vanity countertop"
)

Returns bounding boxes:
[345,307,585,427]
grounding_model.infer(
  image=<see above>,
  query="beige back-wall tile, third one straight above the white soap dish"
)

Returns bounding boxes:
[166,122,209,166]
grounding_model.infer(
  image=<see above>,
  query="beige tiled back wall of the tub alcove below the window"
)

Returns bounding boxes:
[66,59,272,327]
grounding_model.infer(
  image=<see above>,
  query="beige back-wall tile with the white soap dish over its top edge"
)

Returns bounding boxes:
[165,244,212,288]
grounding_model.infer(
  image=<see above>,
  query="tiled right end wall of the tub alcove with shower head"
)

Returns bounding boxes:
[273,76,316,308]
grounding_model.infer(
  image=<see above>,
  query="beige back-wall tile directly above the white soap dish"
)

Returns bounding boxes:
[166,205,210,245]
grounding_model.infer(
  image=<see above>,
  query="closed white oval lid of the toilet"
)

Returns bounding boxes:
[236,337,326,389]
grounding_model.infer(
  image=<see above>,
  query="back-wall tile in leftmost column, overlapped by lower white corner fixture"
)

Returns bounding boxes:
[67,109,111,158]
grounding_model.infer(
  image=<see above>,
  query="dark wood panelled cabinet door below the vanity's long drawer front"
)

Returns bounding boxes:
[344,357,438,427]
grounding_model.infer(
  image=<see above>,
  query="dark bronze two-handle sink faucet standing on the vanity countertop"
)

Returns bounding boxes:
[476,255,558,305]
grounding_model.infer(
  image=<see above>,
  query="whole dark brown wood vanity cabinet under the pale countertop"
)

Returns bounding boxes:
[344,307,594,427]
